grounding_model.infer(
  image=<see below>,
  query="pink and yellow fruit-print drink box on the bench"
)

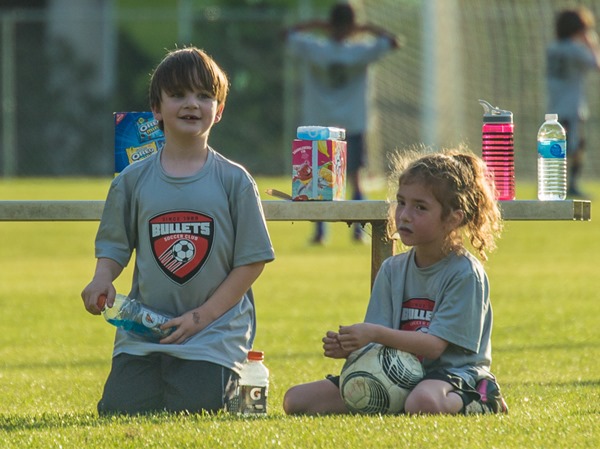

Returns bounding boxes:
[292,139,346,201]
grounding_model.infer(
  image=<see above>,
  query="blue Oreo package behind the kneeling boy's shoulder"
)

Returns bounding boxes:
[113,112,165,173]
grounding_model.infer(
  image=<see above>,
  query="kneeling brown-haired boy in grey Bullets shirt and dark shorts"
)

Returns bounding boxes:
[81,48,274,414]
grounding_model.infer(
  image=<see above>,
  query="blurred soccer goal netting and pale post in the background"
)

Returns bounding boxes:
[358,0,600,181]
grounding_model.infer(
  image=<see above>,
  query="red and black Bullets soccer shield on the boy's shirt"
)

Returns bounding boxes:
[150,211,214,284]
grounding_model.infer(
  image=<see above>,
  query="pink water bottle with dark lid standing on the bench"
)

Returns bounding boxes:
[479,100,515,200]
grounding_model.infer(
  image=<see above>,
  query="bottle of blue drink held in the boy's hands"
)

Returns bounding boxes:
[102,294,175,342]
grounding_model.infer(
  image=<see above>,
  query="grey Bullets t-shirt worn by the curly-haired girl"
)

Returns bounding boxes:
[365,249,492,377]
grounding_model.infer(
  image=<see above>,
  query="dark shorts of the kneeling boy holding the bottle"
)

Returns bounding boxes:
[98,353,238,415]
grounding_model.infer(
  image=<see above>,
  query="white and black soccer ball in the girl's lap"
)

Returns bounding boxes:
[340,343,425,414]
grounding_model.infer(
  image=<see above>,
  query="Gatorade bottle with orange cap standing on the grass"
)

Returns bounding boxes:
[228,351,269,415]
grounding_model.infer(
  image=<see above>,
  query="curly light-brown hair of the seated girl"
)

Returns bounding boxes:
[390,146,502,261]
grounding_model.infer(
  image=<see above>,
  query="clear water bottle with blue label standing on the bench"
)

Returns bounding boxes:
[537,114,567,201]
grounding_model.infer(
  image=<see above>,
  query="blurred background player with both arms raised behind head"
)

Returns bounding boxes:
[286,3,399,244]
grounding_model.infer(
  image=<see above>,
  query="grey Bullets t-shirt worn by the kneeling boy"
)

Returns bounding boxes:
[96,149,274,370]
